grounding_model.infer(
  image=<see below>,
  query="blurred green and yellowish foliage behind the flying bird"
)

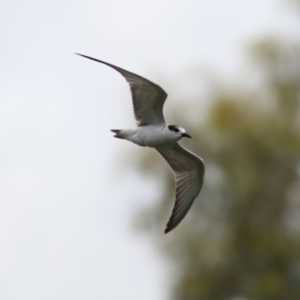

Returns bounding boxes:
[133,40,300,300]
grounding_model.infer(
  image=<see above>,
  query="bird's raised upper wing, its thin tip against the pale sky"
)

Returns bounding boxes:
[75,53,168,126]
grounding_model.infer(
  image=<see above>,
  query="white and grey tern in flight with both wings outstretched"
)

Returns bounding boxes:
[75,53,205,233]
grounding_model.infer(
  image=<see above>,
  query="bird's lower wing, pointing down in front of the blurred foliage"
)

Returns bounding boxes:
[156,143,205,233]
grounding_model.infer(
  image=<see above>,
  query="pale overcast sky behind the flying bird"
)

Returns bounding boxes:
[0,0,299,300]
